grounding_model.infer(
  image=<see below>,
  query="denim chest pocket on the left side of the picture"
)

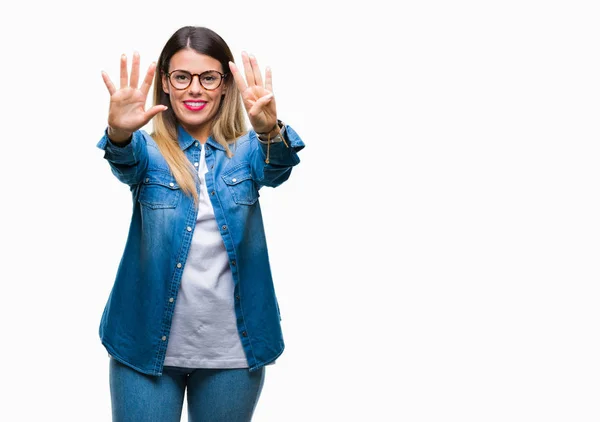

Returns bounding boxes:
[138,171,181,209]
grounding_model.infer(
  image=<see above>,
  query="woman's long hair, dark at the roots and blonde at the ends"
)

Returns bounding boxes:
[151,26,247,204]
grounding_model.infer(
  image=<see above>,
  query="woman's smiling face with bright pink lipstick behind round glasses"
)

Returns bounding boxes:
[162,49,226,141]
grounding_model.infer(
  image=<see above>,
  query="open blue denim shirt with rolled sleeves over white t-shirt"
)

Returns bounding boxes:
[97,126,304,376]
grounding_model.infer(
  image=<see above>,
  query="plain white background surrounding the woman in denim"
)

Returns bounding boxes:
[0,0,600,422]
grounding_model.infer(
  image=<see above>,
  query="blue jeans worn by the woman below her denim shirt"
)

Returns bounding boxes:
[109,358,265,422]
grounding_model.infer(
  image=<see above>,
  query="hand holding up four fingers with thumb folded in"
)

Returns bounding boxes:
[229,51,279,133]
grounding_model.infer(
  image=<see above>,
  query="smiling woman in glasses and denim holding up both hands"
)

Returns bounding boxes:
[98,27,304,422]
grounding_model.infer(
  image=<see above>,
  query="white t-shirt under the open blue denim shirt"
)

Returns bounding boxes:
[164,145,248,368]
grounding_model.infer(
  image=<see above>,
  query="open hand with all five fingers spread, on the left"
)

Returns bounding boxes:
[102,52,167,143]
